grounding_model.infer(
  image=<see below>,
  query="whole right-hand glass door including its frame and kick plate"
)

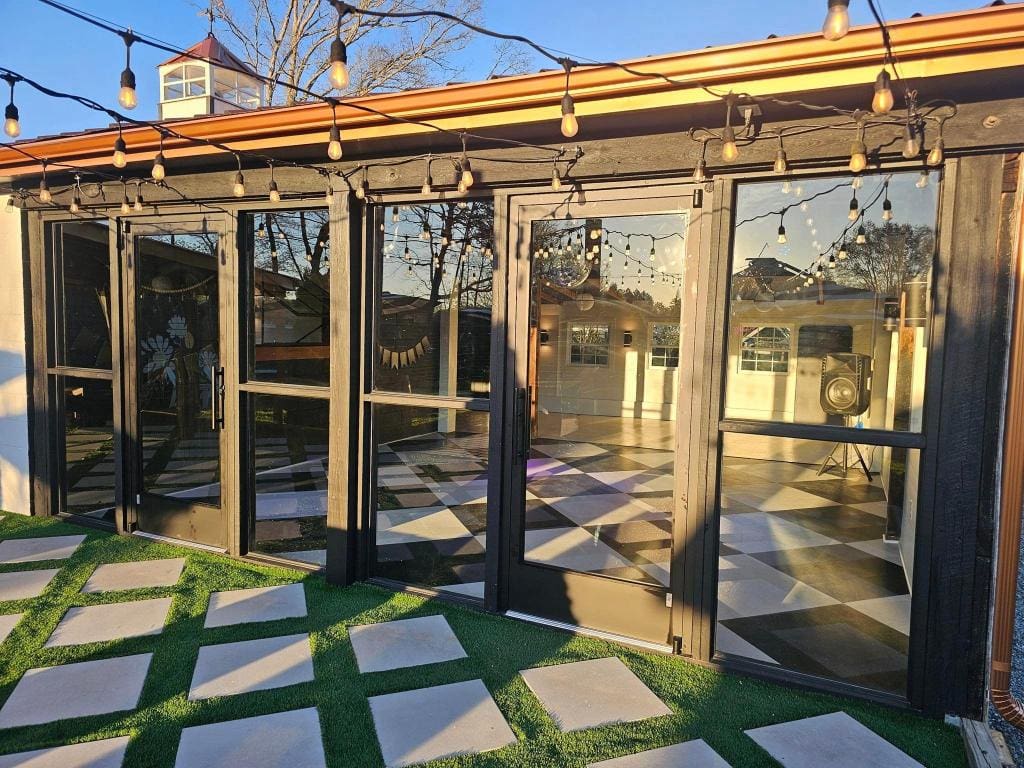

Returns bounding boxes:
[507,187,696,644]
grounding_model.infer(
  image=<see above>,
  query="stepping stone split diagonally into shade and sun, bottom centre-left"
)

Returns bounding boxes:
[370,680,516,768]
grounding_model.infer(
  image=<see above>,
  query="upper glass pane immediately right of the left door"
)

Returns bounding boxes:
[245,208,331,386]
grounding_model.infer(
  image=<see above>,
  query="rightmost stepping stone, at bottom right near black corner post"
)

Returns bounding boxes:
[745,712,924,768]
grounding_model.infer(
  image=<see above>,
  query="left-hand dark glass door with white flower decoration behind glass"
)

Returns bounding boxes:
[125,220,227,548]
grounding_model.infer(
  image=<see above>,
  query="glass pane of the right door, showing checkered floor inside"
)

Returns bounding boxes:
[523,213,688,586]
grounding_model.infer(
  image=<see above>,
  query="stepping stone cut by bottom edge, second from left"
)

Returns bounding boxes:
[174,708,327,768]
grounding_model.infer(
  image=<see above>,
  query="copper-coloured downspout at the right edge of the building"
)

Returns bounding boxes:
[990,154,1024,730]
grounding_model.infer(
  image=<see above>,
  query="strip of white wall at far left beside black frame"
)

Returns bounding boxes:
[0,196,30,515]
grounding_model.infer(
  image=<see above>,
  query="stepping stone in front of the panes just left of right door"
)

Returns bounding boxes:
[348,615,466,672]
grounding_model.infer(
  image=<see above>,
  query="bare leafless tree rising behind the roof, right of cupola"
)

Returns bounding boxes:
[213,0,528,104]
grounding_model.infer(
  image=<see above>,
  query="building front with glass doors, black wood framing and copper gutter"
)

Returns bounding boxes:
[0,5,1024,717]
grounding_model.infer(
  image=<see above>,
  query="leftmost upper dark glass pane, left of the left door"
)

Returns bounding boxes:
[54,221,111,370]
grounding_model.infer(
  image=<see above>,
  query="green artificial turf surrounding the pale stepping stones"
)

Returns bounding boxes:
[0,515,967,768]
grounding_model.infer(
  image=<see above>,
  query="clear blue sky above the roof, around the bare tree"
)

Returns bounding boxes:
[6,0,981,137]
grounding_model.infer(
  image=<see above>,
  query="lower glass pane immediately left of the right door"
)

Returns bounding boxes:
[373,406,488,599]
